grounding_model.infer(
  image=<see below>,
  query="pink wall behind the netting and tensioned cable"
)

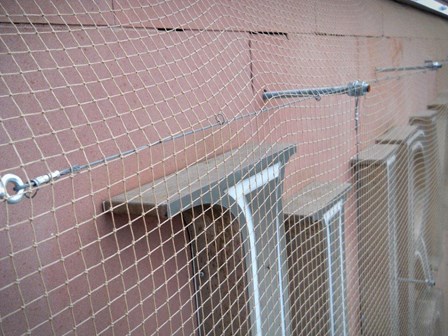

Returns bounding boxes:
[0,0,448,335]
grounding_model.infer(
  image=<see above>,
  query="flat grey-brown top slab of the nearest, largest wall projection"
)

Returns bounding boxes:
[103,144,296,218]
